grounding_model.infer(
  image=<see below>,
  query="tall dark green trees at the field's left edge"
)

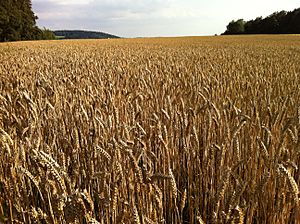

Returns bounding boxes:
[0,0,55,42]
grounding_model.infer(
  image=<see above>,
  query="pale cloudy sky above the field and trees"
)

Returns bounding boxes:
[32,0,300,37]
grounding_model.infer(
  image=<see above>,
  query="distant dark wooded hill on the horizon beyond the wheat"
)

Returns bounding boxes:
[53,30,120,39]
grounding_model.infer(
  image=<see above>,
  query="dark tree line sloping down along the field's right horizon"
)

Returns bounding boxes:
[223,8,300,35]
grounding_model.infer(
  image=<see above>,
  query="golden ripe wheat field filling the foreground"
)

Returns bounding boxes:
[0,35,300,224]
